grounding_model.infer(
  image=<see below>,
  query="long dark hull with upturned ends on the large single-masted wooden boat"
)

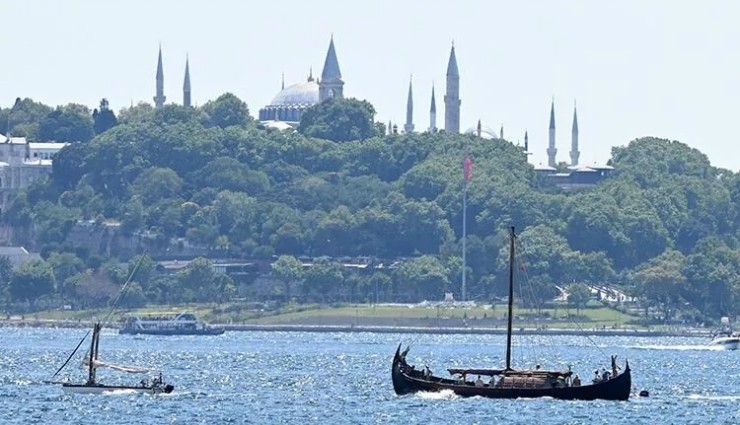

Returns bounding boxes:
[392,346,632,400]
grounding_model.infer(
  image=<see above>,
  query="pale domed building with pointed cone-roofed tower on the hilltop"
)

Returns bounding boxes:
[259,38,344,125]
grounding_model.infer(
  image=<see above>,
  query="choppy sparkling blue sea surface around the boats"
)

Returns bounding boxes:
[0,328,740,425]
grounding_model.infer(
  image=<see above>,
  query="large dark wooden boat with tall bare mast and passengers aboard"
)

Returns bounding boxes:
[391,227,632,400]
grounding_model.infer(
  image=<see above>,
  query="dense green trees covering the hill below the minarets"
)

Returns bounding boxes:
[0,93,740,320]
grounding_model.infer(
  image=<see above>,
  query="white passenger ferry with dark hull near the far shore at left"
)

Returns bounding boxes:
[118,312,224,335]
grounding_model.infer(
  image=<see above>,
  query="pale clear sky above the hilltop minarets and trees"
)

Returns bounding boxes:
[0,0,740,171]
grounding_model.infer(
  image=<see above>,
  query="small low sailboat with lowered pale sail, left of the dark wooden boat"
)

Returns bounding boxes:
[62,322,175,394]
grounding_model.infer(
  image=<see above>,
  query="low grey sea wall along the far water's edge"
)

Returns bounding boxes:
[0,319,711,338]
